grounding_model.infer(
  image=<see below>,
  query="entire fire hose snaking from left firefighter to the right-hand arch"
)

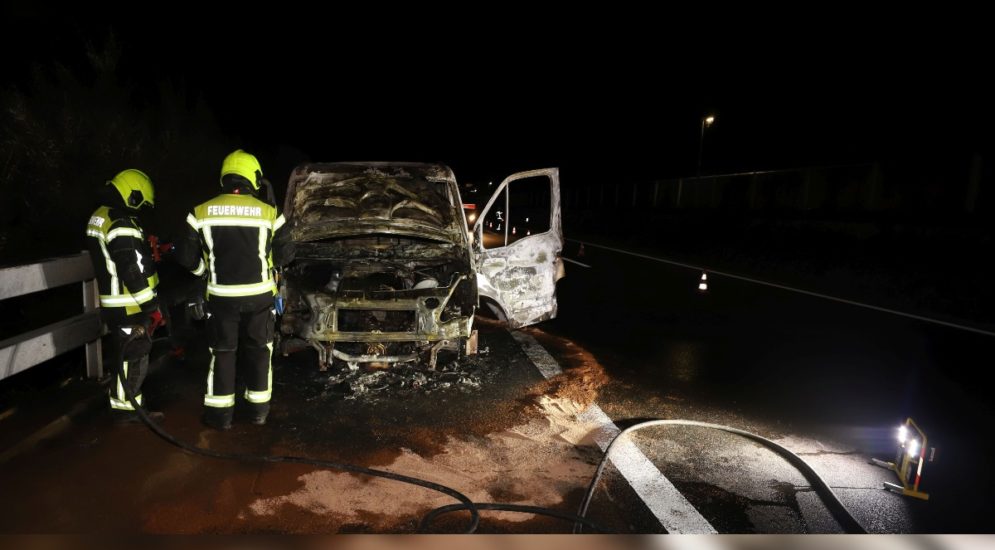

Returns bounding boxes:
[118,325,867,534]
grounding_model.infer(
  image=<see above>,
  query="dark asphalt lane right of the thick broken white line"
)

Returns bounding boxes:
[543,242,995,533]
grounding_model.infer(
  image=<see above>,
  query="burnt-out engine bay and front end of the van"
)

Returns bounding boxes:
[281,234,477,368]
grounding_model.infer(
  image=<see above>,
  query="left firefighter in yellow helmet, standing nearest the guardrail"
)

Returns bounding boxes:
[86,169,163,423]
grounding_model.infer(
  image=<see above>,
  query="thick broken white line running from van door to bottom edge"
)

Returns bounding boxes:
[511,331,717,534]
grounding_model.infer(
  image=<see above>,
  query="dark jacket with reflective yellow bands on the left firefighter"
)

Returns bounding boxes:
[86,206,159,318]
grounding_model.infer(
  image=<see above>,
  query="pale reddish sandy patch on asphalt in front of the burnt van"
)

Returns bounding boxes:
[238,388,612,532]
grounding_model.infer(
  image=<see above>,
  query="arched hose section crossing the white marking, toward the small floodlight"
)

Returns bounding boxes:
[574,420,867,534]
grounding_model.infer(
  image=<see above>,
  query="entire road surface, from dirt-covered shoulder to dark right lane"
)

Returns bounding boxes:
[0,242,992,533]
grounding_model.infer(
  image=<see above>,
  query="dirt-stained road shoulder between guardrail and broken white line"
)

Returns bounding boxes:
[0,324,620,534]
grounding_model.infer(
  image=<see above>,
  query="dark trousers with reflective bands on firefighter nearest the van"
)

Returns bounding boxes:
[204,294,276,425]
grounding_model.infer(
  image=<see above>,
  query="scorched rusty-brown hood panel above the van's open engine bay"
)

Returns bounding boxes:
[287,163,465,243]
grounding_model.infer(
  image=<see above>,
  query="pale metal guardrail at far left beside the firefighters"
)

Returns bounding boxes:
[0,251,103,380]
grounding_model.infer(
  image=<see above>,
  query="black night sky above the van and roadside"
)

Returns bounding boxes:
[0,7,993,189]
